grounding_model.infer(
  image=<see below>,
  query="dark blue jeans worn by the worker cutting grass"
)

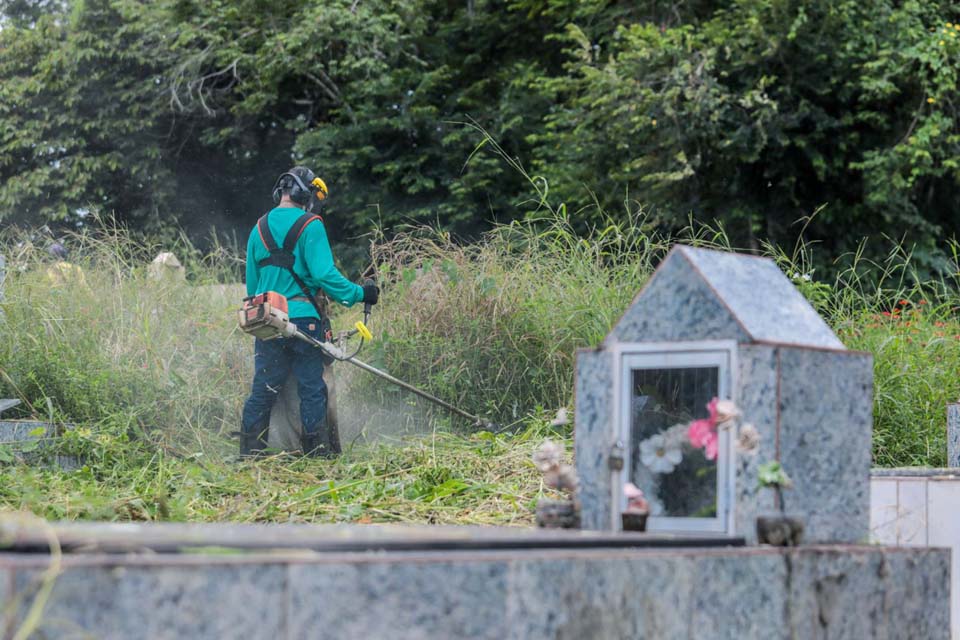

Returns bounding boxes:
[243,318,327,434]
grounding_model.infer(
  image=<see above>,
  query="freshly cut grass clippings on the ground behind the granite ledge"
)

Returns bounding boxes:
[0,426,563,526]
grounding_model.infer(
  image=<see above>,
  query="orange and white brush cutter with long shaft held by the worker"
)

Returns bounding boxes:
[240,291,499,431]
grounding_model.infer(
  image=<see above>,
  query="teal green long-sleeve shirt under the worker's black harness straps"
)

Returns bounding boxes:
[247,207,363,318]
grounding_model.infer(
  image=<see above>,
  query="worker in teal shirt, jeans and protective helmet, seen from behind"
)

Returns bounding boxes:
[240,166,380,457]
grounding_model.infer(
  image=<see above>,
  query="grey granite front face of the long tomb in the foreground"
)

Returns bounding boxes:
[0,546,949,640]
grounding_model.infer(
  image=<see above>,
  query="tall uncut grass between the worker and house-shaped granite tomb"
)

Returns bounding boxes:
[374,218,668,424]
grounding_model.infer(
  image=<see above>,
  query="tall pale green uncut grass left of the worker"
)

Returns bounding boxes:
[0,225,249,450]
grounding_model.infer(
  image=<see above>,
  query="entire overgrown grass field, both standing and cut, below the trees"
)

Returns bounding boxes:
[0,218,960,524]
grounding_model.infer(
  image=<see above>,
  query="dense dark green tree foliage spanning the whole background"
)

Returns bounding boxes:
[0,0,960,269]
